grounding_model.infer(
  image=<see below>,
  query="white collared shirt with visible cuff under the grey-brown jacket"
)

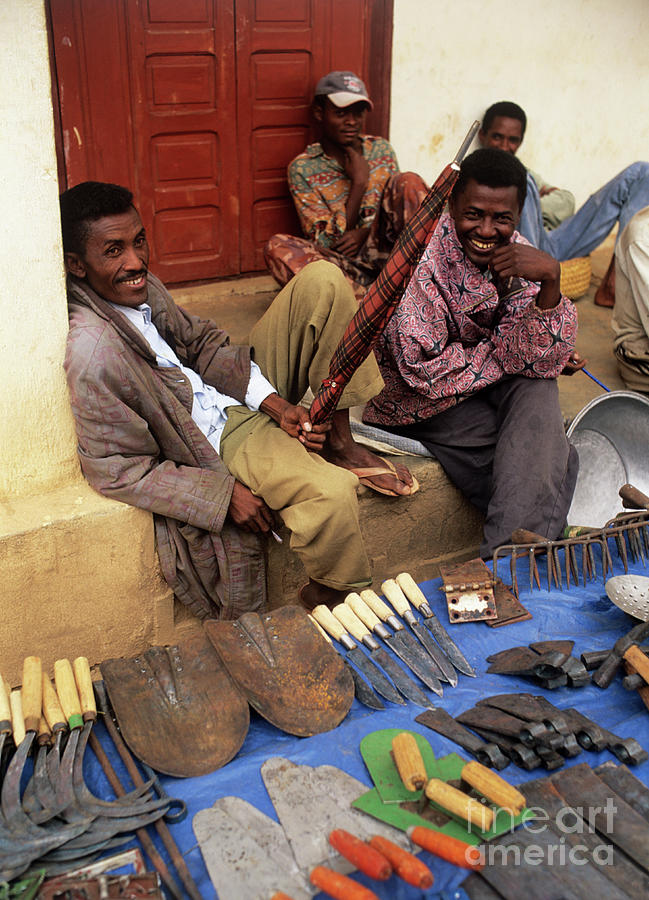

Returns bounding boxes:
[110,303,276,453]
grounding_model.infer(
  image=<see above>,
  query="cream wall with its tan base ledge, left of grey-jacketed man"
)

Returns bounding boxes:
[0,0,174,685]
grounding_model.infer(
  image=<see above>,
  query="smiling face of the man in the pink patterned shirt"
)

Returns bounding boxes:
[449,179,520,269]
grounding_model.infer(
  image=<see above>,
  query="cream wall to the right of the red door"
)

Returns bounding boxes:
[390,0,649,204]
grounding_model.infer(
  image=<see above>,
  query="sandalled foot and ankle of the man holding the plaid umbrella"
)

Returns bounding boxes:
[322,409,414,496]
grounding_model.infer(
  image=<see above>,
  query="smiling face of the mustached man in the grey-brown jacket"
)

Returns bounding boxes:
[66,207,149,308]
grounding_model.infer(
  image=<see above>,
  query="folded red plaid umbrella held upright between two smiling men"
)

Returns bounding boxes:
[310,122,480,425]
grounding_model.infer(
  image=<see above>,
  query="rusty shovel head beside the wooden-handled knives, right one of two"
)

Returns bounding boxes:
[204,606,354,737]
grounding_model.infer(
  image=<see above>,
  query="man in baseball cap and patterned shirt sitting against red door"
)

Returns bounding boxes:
[265,71,427,297]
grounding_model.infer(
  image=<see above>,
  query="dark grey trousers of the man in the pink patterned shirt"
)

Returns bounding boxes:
[391,376,579,557]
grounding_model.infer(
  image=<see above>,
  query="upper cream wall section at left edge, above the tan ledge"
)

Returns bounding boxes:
[0,0,78,501]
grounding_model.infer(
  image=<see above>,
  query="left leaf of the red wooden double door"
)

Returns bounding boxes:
[128,0,239,282]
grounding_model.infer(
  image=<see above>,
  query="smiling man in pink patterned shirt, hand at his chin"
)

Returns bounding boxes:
[364,149,584,556]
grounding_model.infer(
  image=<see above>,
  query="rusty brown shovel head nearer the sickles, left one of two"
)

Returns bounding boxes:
[101,634,250,778]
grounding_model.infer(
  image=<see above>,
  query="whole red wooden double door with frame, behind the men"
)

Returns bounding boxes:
[49,0,392,283]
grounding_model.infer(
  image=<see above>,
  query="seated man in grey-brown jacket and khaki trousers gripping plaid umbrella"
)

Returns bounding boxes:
[61,182,413,618]
